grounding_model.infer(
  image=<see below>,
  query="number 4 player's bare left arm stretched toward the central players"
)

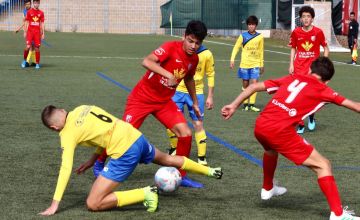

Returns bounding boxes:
[221,82,266,120]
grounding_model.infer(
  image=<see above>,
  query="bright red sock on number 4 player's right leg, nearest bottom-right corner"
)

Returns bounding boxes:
[318,176,343,216]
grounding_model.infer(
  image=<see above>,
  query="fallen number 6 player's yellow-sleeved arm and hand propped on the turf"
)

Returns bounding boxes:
[39,145,75,215]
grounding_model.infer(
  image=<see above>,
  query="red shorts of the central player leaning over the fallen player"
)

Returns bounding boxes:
[123,98,186,129]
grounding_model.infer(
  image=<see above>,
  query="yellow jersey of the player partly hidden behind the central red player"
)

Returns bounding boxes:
[176,45,215,94]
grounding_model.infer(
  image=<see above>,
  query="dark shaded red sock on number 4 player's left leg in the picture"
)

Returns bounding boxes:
[263,153,278,191]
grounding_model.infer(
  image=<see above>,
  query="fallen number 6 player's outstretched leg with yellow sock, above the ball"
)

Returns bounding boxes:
[153,148,223,179]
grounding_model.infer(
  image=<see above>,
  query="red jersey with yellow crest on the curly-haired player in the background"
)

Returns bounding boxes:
[289,26,327,75]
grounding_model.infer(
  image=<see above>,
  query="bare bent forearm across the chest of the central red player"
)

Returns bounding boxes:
[141,53,177,86]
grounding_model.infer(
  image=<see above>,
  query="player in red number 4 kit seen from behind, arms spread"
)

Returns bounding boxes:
[221,57,360,220]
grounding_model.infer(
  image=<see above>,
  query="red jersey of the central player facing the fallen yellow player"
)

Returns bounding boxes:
[129,41,199,103]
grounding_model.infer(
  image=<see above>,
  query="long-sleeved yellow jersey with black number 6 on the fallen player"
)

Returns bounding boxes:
[53,105,141,201]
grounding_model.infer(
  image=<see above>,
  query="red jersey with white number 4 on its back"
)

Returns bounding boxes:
[257,74,345,132]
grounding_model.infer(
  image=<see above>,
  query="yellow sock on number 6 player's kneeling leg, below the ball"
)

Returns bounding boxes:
[114,188,145,207]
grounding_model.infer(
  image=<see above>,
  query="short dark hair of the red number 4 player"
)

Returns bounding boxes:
[310,57,335,82]
